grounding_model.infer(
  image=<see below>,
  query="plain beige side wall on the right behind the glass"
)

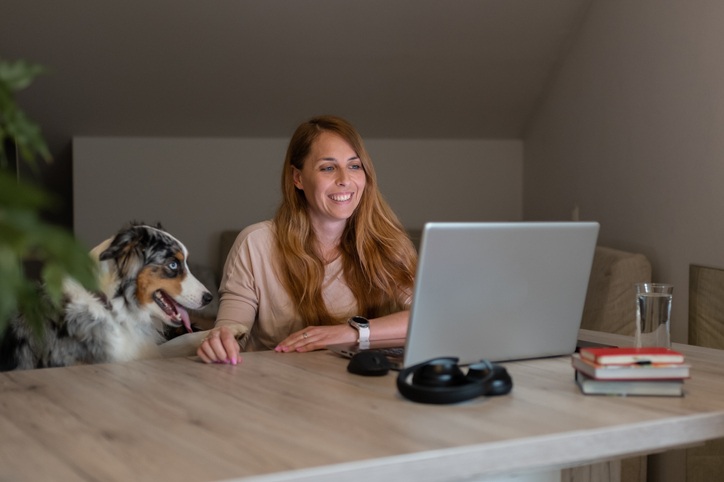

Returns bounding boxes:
[524,0,724,341]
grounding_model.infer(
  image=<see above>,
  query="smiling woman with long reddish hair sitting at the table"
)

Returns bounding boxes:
[197,116,417,364]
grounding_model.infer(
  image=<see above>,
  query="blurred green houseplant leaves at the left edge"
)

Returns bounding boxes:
[0,59,95,334]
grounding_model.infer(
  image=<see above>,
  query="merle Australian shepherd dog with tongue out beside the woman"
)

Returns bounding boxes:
[0,222,213,371]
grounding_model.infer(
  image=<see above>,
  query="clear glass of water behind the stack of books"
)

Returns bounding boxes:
[635,283,674,348]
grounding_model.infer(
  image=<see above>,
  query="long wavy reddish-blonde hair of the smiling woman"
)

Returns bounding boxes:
[274,116,417,326]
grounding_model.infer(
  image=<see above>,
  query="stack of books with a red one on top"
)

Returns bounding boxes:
[572,347,689,397]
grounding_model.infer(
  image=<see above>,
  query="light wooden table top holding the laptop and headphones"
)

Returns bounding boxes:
[0,332,724,482]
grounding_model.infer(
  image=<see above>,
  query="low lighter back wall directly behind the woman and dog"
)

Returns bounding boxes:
[73,137,523,266]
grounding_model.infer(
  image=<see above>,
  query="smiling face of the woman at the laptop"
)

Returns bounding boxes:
[293,131,366,228]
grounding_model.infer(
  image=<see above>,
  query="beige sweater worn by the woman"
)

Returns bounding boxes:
[216,221,360,351]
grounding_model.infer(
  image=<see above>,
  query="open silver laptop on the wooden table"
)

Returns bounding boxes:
[328,222,599,368]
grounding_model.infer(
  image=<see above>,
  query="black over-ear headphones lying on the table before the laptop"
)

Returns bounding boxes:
[397,357,513,404]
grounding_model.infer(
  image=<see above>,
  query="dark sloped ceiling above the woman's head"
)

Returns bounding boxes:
[0,0,591,138]
